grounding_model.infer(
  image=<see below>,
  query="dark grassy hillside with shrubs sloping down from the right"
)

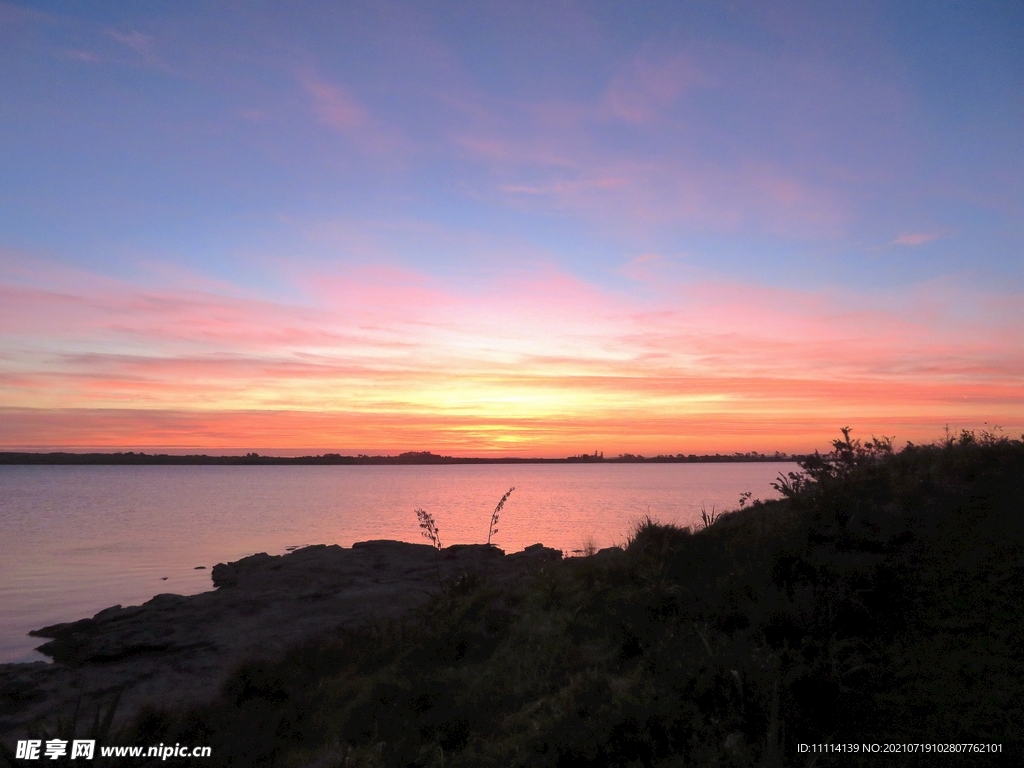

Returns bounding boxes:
[4,431,1024,768]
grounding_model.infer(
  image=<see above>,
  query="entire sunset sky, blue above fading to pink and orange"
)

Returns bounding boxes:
[0,0,1024,457]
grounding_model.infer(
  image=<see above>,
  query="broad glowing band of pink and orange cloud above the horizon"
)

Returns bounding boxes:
[0,259,1024,455]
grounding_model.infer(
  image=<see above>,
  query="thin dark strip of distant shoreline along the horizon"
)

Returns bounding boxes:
[0,451,803,466]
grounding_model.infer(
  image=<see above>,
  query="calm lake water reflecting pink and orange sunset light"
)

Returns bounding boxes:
[0,463,795,662]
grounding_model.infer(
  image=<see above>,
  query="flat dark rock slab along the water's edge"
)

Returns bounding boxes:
[0,541,561,740]
